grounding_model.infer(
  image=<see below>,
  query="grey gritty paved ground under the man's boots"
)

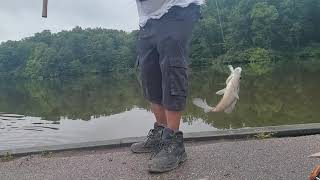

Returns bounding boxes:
[0,135,320,180]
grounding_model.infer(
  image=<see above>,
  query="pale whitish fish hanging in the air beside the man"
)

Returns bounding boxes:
[192,65,242,114]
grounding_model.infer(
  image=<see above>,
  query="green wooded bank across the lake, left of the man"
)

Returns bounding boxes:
[0,27,137,79]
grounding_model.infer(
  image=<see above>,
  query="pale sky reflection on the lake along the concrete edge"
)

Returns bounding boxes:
[0,108,216,150]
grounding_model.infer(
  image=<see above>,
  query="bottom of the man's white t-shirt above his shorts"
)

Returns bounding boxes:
[136,0,204,27]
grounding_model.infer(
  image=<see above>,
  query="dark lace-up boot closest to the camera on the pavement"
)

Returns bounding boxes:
[149,128,187,173]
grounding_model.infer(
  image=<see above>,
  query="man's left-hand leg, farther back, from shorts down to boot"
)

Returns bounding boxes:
[131,28,167,153]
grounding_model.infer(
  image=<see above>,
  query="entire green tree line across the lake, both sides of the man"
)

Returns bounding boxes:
[0,0,320,79]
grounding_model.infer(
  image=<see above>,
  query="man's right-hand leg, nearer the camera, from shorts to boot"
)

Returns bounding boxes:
[148,5,199,172]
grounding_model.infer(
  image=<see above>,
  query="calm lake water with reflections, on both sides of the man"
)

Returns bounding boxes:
[0,60,320,150]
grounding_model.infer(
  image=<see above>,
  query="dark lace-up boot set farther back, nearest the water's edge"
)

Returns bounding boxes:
[131,123,164,153]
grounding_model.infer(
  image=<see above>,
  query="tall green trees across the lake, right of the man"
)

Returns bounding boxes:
[191,0,320,65]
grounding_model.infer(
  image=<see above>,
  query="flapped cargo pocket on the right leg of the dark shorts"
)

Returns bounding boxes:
[169,58,188,96]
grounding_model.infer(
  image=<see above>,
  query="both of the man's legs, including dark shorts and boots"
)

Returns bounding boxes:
[131,2,199,172]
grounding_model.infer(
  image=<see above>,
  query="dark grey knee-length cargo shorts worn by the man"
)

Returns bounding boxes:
[137,4,200,111]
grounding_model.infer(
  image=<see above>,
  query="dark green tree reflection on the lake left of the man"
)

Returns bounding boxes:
[0,75,147,121]
